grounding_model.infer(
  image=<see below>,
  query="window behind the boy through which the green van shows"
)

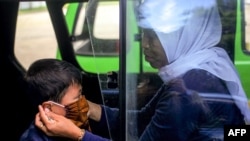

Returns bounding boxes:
[62,0,119,74]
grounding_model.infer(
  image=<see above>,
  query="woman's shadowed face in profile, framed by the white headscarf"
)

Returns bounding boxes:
[142,29,168,69]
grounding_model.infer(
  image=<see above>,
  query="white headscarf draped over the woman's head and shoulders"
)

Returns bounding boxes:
[138,0,250,123]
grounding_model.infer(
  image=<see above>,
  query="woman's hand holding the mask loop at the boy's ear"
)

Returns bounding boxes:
[35,105,84,140]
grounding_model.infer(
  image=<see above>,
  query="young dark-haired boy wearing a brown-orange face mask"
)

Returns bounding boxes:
[20,59,90,141]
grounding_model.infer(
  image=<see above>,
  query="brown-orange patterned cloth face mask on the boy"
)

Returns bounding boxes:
[65,96,91,131]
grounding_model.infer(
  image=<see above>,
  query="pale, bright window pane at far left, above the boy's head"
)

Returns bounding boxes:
[14,2,57,69]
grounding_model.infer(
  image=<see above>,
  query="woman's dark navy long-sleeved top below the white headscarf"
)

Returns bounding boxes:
[96,69,245,141]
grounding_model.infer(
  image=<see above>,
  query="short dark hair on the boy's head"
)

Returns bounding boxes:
[24,59,82,107]
